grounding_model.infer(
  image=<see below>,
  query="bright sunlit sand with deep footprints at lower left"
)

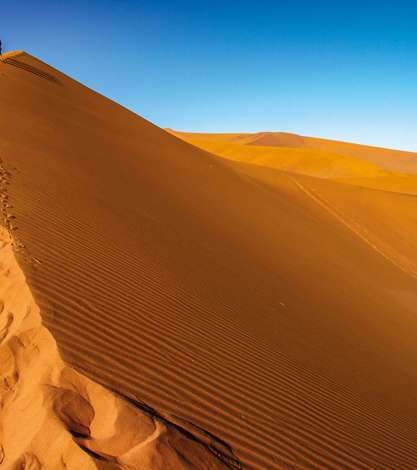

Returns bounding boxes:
[0,193,234,470]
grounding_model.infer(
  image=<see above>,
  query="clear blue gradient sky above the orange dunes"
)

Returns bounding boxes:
[0,0,417,150]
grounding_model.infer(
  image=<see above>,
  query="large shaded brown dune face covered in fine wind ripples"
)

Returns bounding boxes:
[0,54,417,470]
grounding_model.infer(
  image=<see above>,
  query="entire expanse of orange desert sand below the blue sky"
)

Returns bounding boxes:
[0,53,417,470]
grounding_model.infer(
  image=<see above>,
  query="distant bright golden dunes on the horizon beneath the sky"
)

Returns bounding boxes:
[169,129,417,185]
